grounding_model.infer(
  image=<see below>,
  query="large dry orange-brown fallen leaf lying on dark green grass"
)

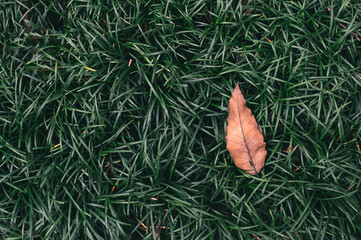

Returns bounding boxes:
[226,83,267,175]
